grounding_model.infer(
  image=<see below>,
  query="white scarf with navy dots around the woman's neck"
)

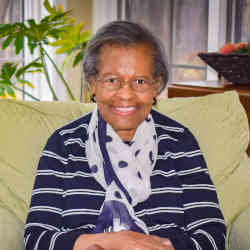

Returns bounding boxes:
[86,108,158,234]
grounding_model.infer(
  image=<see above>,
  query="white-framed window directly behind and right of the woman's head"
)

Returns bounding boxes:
[93,0,231,85]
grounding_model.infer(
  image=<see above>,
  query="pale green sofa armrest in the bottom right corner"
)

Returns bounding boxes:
[227,206,250,250]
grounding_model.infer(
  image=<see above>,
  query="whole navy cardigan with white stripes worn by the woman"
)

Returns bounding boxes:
[24,110,226,250]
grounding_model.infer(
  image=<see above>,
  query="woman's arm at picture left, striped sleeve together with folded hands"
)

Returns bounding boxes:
[24,132,172,250]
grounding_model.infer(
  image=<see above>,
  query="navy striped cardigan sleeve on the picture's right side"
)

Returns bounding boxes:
[166,129,226,250]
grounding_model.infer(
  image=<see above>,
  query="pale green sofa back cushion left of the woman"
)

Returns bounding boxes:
[0,100,93,221]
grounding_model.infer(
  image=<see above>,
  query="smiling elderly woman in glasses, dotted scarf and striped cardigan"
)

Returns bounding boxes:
[25,21,226,250]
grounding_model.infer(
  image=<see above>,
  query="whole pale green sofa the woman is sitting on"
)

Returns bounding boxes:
[0,91,250,250]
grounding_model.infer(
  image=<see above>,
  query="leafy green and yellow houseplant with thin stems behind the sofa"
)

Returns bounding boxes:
[0,0,90,101]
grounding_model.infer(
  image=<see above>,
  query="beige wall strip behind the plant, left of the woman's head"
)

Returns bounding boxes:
[66,0,92,101]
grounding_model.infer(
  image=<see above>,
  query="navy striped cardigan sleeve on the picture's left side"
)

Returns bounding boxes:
[24,132,91,250]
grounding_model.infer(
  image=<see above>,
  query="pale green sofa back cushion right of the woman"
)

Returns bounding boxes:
[158,91,250,224]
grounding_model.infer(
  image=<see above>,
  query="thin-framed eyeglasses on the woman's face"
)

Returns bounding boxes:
[97,76,156,93]
